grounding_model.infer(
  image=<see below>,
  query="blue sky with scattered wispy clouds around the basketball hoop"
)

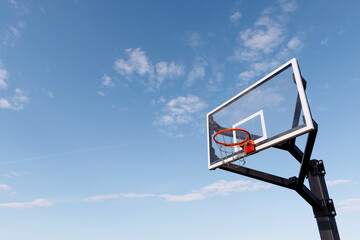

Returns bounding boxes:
[0,0,360,240]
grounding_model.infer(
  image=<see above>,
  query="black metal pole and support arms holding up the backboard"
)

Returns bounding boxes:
[219,121,340,240]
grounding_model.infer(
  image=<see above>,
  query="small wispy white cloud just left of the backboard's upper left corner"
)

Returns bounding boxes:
[154,94,207,126]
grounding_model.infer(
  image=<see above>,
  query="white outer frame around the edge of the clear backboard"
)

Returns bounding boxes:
[207,58,314,169]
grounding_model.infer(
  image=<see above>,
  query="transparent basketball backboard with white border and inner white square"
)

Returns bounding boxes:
[207,58,314,169]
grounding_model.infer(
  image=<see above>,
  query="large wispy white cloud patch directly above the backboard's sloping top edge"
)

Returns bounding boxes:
[233,0,304,85]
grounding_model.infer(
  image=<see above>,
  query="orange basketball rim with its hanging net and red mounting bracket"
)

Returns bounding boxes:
[213,128,255,165]
